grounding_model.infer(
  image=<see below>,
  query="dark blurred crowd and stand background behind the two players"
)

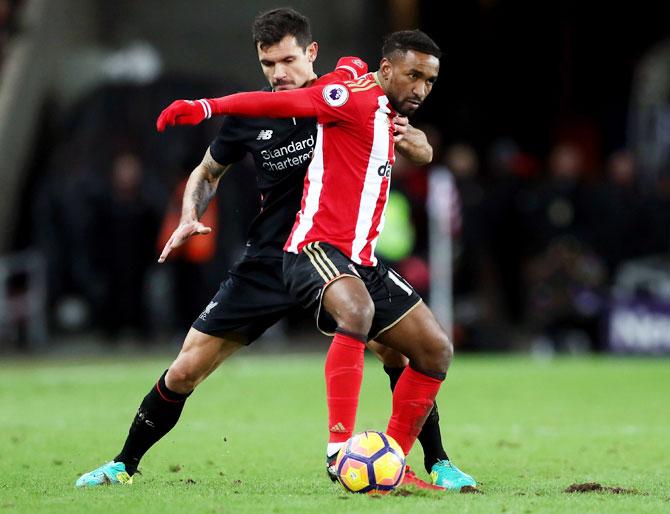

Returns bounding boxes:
[0,0,670,352]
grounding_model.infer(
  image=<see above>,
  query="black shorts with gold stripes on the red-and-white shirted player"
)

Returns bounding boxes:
[284,242,421,339]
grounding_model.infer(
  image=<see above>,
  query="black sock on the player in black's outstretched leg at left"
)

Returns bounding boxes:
[114,370,191,475]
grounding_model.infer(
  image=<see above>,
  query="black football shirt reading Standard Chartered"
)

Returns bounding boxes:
[209,88,316,258]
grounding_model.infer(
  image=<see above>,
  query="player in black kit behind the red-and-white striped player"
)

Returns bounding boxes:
[76,8,472,489]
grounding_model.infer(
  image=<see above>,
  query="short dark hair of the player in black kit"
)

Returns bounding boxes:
[251,7,313,48]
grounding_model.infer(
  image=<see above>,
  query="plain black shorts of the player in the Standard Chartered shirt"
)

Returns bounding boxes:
[193,258,302,344]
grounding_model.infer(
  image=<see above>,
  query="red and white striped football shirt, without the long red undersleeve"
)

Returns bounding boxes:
[284,74,395,266]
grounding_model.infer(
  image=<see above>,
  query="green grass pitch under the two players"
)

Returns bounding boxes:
[0,351,670,514]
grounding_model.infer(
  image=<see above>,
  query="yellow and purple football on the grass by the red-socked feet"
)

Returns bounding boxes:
[335,431,405,493]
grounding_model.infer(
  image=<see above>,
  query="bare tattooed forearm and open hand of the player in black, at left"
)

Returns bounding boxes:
[158,148,228,262]
